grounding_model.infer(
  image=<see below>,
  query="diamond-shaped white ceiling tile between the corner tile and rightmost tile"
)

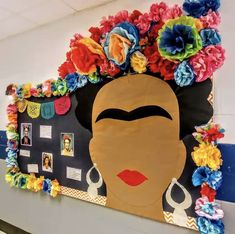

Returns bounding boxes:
[20,0,75,24]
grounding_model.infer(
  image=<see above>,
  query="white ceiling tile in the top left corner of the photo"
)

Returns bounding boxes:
[0,0,45,12]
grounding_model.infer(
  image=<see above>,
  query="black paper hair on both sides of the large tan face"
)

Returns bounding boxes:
[76,74,213,139]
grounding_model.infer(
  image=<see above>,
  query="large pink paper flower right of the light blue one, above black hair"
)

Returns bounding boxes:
[189,45,225,82]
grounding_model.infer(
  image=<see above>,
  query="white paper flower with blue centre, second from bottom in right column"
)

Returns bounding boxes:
[195,197,224,220]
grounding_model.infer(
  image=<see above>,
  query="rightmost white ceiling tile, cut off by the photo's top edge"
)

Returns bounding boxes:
[63,0,112,11]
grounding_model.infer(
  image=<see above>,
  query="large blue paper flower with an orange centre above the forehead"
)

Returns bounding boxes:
[104,22,140,70]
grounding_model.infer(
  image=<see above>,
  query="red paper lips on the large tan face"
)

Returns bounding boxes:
[117,170,148,186]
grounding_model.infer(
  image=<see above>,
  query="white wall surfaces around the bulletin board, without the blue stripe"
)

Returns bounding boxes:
[0,0,235,234]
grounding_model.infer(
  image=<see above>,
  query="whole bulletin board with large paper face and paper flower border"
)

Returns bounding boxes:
[6,0,225,233]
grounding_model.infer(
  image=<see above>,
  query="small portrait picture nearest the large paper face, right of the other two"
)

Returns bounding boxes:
[60,133,74,157]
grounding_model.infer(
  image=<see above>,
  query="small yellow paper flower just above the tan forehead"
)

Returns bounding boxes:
[131,51,148,73]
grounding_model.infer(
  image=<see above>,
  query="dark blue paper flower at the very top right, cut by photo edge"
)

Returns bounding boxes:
[183,0,220,18]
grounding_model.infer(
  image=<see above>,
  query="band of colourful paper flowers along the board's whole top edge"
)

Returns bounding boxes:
[6,0,225,99]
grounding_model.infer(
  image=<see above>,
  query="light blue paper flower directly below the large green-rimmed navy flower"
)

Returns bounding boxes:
[174,61,195,87]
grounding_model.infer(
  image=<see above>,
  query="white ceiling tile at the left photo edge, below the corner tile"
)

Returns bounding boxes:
[0,15,36,39]
